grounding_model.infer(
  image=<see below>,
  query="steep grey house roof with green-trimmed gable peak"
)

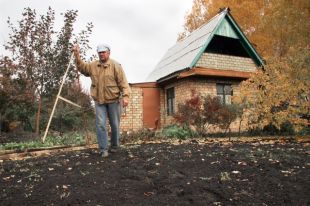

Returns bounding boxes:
[146,8,263,81]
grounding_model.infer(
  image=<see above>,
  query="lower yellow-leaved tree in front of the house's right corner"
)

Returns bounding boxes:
[241,46,310,130]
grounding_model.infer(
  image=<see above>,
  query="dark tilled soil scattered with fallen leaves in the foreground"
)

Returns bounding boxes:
[0,141,310,206]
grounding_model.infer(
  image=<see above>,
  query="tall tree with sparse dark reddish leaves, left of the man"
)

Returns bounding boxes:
[1,8,93,134]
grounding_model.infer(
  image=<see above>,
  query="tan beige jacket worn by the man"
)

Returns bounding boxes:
[76,58,130,104]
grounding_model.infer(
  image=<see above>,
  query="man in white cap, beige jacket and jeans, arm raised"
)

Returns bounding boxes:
[73,44,130,157]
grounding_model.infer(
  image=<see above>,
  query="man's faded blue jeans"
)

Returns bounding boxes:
[95,102,121,152]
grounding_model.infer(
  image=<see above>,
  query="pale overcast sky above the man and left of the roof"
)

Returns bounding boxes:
[0,0,192,87]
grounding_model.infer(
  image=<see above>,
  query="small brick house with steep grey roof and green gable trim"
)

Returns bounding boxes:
[121,9,263,131]
